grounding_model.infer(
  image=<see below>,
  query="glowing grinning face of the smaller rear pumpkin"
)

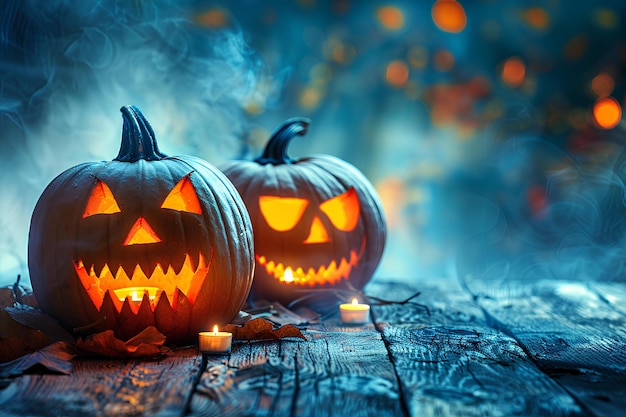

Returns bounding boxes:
[256,187,365,286]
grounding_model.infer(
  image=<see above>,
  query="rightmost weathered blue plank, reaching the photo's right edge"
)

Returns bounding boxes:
[470,281,626,416]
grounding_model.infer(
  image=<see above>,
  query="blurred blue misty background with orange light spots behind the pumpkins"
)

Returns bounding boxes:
[0,0,626,285]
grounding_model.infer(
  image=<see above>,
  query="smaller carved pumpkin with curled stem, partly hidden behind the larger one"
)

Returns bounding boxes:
[221,118,386,302]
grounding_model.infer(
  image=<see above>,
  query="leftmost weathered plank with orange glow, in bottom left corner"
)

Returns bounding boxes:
[0,348,202,417]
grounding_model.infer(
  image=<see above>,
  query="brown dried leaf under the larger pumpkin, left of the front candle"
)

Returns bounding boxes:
[77,326,165,358]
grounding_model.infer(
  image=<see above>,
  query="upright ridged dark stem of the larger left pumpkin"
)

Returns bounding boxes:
[114,106,167,162]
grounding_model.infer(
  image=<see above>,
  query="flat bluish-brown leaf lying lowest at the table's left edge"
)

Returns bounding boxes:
[0,342,76,378]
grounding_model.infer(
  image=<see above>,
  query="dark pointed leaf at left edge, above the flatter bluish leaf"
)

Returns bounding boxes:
[0,310,50,363]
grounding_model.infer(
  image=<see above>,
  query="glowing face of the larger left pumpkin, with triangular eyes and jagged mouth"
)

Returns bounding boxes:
[74,173,211,312]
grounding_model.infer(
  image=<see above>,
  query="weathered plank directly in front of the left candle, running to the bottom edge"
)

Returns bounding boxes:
[191,329,404,417]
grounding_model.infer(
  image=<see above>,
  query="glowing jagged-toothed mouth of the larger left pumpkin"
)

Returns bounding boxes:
[74,253,211,313]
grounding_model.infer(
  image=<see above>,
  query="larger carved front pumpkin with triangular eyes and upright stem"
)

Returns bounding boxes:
[28,106,254,342]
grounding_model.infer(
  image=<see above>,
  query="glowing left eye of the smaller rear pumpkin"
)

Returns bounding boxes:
[259,196,309,232]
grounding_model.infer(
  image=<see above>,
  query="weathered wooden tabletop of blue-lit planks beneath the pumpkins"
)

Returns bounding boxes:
[0,279,626,417]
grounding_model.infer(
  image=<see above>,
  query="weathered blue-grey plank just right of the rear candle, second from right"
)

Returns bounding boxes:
[368,280,582,416]
